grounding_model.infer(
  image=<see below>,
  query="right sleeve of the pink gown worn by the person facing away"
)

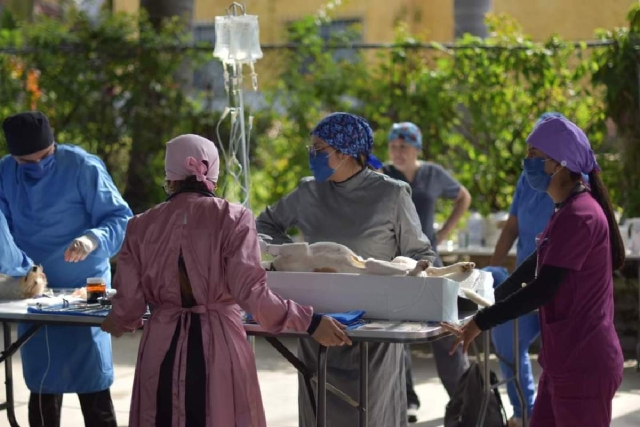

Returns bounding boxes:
[223,210,313,333]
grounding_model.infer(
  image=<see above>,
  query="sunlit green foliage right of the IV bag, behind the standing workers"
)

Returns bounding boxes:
[260,9,603,214]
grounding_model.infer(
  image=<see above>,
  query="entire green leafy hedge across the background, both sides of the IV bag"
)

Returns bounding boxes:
[0,5,640,221]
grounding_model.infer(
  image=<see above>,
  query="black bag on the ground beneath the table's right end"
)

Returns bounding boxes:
[444,363,507,427]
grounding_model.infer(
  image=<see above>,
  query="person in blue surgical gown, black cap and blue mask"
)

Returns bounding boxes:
[0,111,132,427]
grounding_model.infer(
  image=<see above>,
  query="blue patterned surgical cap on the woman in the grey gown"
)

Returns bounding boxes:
[311,113,382,169]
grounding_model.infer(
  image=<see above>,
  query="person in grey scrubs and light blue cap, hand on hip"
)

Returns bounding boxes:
[382,122,471,423]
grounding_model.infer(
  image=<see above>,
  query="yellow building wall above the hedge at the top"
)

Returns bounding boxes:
[114,0,634,43]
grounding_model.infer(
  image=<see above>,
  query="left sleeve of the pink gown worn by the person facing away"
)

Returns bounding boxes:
[109,220,147,332]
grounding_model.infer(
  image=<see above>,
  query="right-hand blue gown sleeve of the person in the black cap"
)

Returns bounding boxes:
[78,155,133,258]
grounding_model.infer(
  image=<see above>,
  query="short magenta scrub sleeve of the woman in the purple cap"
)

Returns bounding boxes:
[539,215,592,271]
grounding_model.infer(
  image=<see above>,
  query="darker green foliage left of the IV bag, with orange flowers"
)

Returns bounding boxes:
[0,11,214,212]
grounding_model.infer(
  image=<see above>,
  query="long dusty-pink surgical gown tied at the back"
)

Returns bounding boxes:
[111,193,313,427]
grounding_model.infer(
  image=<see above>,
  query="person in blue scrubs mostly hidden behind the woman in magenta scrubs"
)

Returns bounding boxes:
[484,112,588,427]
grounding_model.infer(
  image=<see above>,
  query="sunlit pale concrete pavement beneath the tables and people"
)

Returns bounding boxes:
[0,332,640,427]
